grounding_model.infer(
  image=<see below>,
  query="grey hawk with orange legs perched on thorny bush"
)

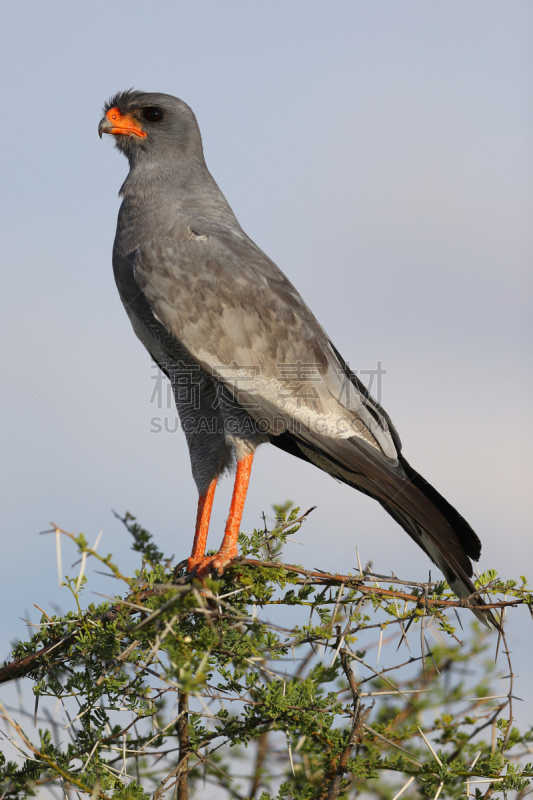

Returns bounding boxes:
[98,89,497,627]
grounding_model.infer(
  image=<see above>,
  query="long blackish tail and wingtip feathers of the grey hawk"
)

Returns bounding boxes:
[271,433,499,629]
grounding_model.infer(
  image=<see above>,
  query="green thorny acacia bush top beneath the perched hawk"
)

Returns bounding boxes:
[0,507,533,800]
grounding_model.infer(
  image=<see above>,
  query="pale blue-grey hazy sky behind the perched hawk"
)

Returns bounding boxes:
[0,0,533,724]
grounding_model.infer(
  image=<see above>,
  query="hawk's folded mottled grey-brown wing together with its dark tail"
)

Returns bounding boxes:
[129,224,497,625]
